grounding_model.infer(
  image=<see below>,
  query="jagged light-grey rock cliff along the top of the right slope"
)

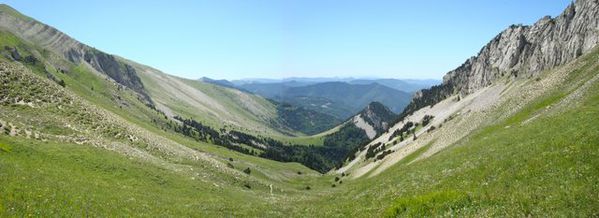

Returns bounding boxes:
[402,0,599,116]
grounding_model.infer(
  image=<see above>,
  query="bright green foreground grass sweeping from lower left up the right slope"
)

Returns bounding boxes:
[0,48,599,217]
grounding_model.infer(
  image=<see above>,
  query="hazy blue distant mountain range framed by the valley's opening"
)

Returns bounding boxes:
[200,77,440,120]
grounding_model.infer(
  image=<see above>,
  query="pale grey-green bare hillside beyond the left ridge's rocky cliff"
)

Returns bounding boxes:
[137,65,296,135]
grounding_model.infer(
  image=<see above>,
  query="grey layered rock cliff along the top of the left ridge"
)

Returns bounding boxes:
[0,4,151,103]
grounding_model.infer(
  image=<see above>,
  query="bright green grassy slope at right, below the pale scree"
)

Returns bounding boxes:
[284,48,599,217]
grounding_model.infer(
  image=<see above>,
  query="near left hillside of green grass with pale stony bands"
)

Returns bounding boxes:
[0,19,338,216]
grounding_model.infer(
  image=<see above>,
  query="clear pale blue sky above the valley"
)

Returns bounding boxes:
[4,0,570,79]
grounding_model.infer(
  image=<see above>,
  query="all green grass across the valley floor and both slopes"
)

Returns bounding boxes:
[0,12,599,217]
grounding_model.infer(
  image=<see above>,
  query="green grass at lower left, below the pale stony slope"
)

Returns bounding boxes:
[0,138,284,216]
